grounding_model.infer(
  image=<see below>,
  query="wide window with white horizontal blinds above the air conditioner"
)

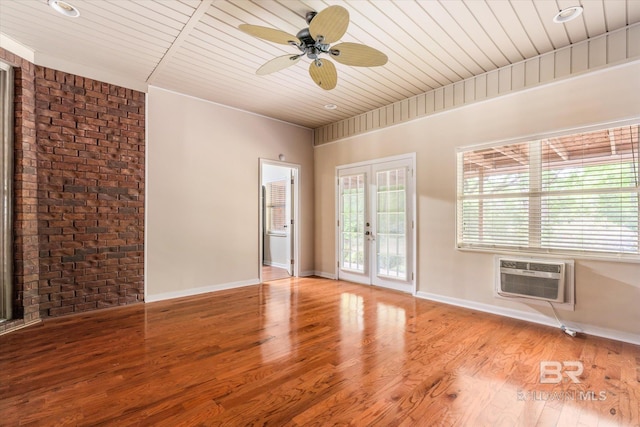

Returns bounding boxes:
[457,124,640,258]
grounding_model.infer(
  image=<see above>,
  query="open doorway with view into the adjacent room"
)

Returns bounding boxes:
[260,159,299,282]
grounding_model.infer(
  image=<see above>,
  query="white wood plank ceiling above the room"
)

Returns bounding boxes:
[0,0,640,128]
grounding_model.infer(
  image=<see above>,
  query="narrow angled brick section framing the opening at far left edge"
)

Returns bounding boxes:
[0,48,40,333]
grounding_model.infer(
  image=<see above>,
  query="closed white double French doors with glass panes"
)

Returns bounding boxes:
[337,158,415,293]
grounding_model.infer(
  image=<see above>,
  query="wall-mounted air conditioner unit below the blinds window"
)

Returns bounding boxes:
[495,257,573,304]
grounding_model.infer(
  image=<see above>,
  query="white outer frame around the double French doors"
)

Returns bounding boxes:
[334,152,418,295]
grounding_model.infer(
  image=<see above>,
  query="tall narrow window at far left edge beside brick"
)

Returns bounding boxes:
[0,62,13,321]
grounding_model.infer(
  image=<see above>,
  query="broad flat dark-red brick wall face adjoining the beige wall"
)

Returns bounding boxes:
[35,67,145,317]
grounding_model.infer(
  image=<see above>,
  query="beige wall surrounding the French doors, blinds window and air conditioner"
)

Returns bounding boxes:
[314,61,640,343]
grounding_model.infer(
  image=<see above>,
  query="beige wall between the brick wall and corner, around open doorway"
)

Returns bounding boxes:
[145,87,314,301]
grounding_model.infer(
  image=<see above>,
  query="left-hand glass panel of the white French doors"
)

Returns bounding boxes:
[340,174,365,273]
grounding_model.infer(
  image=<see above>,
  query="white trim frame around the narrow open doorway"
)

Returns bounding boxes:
[258,158,302,283]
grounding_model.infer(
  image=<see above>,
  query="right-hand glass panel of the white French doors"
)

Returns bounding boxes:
[376,168,407,280]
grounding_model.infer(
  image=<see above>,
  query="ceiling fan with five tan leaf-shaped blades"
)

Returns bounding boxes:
[238,6,387,90]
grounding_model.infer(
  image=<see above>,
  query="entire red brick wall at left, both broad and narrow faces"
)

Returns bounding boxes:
[0,48,145,333]
